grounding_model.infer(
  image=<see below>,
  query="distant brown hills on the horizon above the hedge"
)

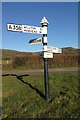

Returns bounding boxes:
[0,47,79,60]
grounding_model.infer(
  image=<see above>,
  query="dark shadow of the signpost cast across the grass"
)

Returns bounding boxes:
[2,74,46,100]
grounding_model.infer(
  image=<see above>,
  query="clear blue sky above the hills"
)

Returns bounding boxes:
[2,2,78,52]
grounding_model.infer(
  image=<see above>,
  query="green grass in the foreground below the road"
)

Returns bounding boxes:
[2,72,80,120]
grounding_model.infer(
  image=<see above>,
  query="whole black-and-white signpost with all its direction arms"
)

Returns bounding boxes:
[7,17,62,100]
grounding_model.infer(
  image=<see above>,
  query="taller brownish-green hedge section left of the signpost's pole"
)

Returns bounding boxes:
[12,56,43,69]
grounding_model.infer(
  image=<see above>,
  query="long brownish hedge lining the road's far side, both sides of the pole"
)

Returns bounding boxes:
[3,55,79,70]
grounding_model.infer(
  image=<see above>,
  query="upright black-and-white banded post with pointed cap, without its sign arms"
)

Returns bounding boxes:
[41,17,50,100]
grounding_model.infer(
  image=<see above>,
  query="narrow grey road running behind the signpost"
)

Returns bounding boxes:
[0,67,80,75]
